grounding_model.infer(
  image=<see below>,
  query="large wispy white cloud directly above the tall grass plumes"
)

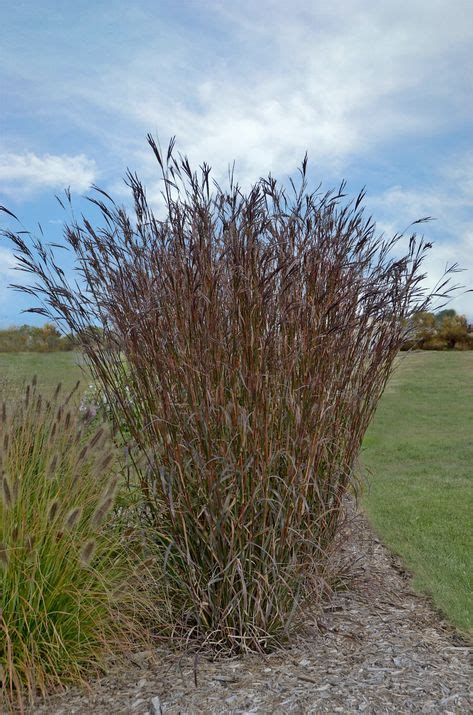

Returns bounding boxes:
[57,0,473,183]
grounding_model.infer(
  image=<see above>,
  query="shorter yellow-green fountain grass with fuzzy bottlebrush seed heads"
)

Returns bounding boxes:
[0,386,148,703]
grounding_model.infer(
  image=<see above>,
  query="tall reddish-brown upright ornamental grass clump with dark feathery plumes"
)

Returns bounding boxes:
[0,137,454,651]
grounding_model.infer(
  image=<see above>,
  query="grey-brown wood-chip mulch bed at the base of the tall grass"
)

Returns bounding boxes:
[31,515,473,715]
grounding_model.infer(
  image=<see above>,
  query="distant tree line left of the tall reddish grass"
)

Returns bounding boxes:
[0,323,75,353]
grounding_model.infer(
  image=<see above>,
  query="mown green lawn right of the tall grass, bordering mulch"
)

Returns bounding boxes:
[363,352,473,632]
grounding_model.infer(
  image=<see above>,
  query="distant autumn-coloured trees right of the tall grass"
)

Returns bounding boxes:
[402,309,473,350]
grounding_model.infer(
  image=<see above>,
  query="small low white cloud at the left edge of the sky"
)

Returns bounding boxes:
[0,152,97,197]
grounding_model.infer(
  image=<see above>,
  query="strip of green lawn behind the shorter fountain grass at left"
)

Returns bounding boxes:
[0,352,88,396]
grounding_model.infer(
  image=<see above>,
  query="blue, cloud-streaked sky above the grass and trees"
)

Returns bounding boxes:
[0,0,473,327]
